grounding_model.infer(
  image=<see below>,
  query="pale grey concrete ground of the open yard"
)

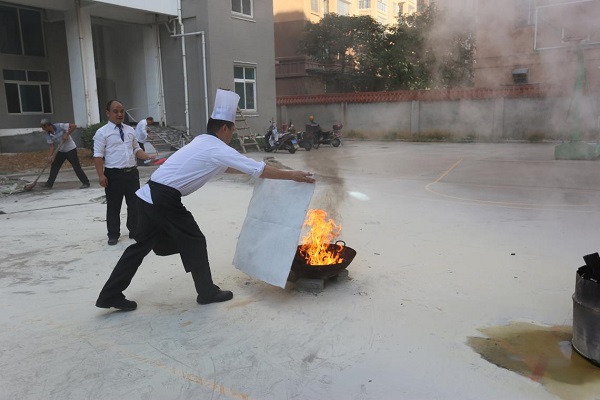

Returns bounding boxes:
[0,141,600,400]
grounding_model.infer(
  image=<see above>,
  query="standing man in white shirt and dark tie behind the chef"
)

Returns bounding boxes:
[94,100,155,246]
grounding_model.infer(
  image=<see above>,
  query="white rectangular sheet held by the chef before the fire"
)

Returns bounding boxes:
[233,179,315,288]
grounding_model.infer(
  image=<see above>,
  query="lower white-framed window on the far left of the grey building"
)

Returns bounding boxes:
[2,69,52,114]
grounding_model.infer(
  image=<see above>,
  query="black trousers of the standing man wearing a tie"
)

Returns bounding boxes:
[104,168,140,239]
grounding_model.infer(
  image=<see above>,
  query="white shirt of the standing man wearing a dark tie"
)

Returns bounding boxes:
[94,122,141,168]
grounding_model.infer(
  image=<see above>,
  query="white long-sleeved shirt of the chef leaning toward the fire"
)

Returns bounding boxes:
[136,134,265,204]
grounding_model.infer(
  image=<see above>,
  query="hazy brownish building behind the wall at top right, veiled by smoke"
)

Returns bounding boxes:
[474,0,600,93]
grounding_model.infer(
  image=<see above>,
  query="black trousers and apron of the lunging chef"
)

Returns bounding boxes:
[98,182,219,300]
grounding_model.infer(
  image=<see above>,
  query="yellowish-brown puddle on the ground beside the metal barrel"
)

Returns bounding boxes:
[467,322,600,400]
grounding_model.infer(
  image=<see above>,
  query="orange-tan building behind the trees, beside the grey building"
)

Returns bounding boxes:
[273,0,429,96]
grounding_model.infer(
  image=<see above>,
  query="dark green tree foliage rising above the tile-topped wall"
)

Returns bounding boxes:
[301,6,474,92]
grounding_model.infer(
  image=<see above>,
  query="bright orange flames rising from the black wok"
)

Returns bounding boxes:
[300,209,344,265]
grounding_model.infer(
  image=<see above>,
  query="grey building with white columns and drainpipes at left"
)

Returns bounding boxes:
[0,0,276,151]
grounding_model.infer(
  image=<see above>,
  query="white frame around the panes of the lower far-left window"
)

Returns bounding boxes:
[2,68,54,115]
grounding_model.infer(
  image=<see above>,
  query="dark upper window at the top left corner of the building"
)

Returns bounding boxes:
[0,6,46,57]
